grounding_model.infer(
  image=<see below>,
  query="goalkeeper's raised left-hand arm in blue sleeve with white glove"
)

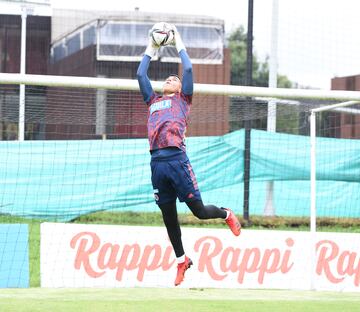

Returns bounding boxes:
[136,36,159,103]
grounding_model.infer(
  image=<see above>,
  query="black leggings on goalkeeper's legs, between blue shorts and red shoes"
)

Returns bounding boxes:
[159,200,226,257]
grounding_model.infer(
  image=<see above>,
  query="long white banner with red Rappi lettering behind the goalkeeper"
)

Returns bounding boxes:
[40,223,360,291]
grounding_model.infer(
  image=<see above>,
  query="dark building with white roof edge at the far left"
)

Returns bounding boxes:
[0,0,51,140]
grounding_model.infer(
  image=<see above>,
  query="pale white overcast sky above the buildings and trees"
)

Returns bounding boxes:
[51,0,360,89]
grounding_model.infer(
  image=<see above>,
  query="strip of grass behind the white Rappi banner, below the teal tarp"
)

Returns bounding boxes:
[0,211,360,288]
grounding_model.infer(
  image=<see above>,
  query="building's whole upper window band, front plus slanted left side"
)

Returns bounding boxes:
[53,20,224,64]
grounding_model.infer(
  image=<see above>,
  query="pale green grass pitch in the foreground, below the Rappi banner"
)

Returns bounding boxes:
[0,288,360,312]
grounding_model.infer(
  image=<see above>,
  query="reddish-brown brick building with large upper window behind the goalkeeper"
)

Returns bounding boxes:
[47,10,230,138]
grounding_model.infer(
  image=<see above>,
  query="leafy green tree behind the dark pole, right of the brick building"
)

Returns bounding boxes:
[228,26,293,88]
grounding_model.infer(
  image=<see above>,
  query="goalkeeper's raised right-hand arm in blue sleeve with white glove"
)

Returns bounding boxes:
[173,26,194,95]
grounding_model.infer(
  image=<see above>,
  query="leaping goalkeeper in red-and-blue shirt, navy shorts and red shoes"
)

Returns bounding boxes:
[137,25,241,286]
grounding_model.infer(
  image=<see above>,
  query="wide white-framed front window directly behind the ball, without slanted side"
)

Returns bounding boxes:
[98,21,224,64]
